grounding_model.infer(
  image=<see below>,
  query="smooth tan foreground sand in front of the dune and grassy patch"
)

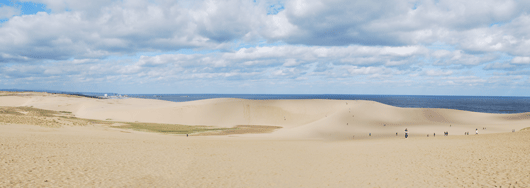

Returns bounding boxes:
[0,125,530,187]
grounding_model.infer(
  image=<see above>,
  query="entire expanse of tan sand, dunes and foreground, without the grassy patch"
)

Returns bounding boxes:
[0,93,530,187]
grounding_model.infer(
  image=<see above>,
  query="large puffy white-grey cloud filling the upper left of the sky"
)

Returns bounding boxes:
[0,1,263,61]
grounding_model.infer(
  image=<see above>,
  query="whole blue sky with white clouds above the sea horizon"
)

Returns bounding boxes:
[0,0,530,96]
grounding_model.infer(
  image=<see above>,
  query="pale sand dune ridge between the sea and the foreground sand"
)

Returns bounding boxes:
[0,94,530,139]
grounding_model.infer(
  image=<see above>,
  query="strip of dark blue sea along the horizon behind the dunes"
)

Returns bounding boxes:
[4,89,530,114]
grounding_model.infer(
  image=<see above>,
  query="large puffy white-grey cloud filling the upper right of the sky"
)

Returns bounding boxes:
[262,0,528,46]
